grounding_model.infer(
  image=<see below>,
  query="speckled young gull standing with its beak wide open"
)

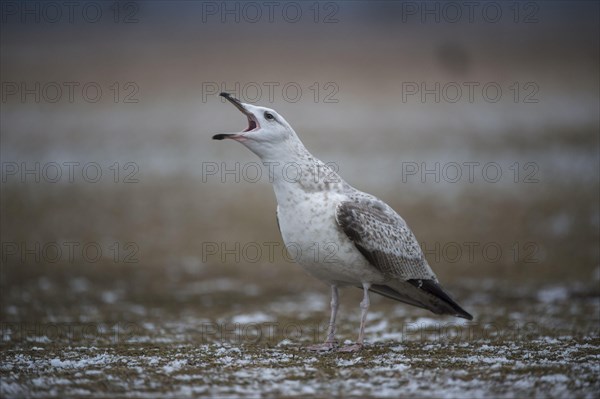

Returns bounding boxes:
[213,93,473,352]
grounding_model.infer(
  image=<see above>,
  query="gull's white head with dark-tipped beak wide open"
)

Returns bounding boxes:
[213,93,304,159]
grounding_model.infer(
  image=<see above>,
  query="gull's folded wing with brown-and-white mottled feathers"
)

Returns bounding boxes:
[336,196,437,281]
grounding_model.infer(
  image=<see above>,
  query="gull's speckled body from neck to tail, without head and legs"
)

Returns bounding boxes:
[274,158,470,318]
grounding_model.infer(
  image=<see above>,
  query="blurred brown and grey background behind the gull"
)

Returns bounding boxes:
[0,1,600,396]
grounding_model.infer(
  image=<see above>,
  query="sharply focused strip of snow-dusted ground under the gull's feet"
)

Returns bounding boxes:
[0,338,600,398]
